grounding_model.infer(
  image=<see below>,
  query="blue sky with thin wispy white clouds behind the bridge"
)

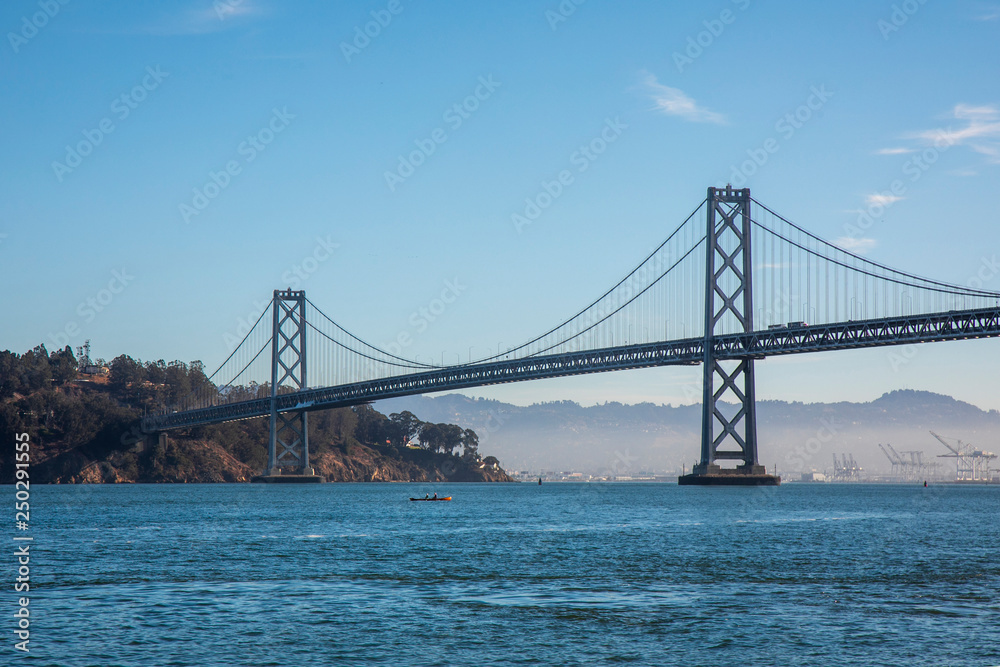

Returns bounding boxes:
[0,0,1000,408]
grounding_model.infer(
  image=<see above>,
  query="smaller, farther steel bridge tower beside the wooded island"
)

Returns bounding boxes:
[255,289,322,482]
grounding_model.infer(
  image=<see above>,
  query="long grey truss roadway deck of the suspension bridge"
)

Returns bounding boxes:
[142,304,1000,433]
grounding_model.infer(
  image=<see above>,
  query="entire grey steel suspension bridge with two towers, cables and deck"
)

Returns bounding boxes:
[142,186,1000,485]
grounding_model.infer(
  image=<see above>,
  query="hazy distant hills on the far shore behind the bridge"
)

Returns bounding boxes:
[376,390,1000,475]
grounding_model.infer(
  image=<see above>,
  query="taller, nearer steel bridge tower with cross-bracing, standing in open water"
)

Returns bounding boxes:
[678,185,781,486]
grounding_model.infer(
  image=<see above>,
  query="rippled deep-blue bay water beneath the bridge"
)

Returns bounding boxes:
[28,484,1000,667]
